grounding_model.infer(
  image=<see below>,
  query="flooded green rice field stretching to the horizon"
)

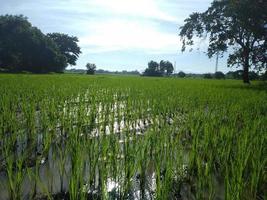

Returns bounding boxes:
[0,74,267,200]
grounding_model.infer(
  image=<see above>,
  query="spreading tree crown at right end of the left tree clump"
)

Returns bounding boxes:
[47,33,81,65]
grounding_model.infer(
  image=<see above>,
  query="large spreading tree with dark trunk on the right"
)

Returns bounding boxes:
[180,0,267,83]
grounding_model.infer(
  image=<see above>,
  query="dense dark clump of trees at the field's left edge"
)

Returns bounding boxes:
[0,15,81,73]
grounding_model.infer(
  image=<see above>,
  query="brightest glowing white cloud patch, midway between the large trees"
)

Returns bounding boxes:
[80,19,179,53]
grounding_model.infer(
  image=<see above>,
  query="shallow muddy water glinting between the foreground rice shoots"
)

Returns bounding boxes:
[0,98,195,200]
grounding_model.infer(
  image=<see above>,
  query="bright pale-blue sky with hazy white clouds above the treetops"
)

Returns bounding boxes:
[0,0,230,73]
